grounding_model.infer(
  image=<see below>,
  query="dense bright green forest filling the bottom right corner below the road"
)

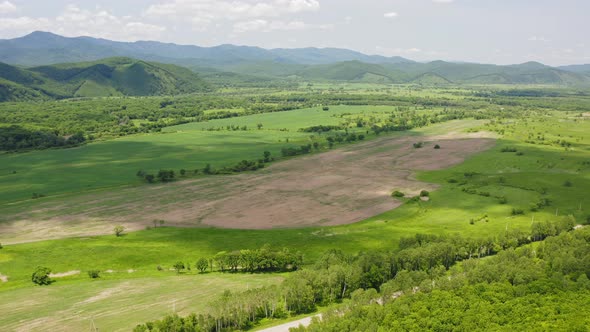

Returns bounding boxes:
[298,230,590,331]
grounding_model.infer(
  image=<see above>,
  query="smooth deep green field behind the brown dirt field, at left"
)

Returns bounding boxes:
[0,106,402,204]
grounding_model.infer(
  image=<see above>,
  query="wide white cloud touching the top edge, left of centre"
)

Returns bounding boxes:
[144,0,320,30]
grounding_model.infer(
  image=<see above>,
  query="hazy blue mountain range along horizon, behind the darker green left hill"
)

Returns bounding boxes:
[0,32,590,86]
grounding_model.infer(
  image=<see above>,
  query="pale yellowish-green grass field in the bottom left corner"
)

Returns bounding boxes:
[0,271,283,331]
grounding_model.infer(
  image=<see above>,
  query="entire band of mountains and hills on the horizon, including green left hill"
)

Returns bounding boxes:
[0,32,590,100]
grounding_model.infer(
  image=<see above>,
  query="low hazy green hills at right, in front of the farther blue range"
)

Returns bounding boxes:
[268,61,590,85]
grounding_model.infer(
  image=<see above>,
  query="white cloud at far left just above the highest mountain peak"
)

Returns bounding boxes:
[0,5,166,41]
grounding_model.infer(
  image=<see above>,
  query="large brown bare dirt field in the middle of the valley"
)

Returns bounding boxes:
[0,133,494,243]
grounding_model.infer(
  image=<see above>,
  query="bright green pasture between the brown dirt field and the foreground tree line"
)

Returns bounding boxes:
[0,115,590,289]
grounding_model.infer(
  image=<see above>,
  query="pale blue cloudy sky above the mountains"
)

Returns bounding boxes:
[0,0,590,65]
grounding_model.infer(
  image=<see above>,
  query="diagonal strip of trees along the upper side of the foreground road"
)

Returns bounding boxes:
[135,218,590,332]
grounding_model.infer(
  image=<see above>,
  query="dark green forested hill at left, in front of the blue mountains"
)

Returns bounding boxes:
[0,58,210,101]
